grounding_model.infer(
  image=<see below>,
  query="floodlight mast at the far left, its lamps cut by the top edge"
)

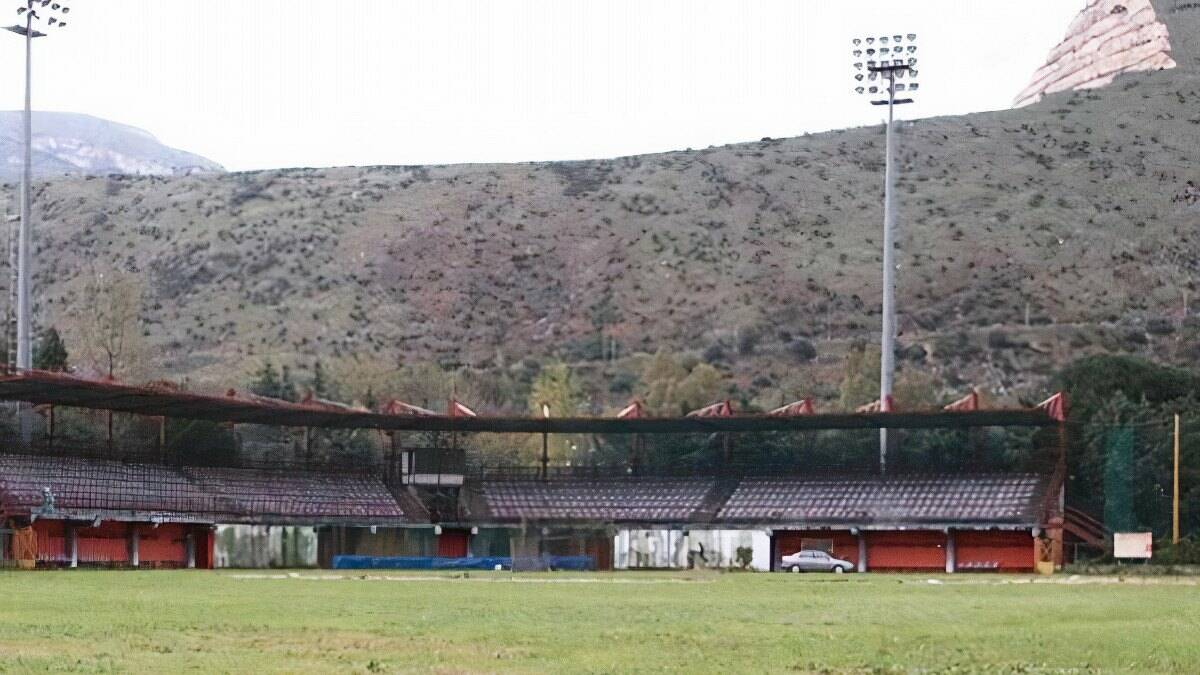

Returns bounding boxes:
[5,0,71,370]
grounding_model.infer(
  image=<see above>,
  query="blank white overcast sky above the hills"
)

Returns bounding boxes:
[0,0,1084,171]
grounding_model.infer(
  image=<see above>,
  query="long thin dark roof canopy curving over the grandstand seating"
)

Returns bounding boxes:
[0,370,1062,434]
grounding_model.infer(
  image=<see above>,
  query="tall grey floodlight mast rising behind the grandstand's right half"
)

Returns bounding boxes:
[851,32,919,473]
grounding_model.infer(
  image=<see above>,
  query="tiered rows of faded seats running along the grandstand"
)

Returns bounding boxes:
[0,454,1048,527]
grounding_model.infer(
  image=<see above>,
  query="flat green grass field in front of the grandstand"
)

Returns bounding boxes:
[0,571,1200,673]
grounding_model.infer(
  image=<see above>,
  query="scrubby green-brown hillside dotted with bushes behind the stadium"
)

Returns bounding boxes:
[4,0,1200,403]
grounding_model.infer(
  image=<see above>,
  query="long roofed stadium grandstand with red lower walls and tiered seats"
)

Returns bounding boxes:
[0,371,1080,572]
